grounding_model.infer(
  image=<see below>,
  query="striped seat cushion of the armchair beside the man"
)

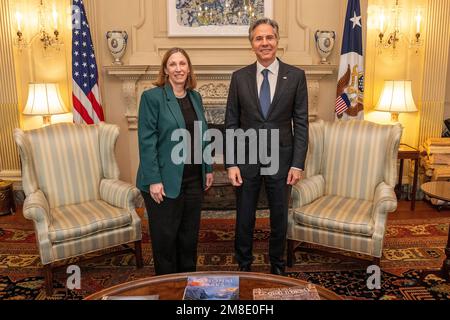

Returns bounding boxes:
[294,195,374,237]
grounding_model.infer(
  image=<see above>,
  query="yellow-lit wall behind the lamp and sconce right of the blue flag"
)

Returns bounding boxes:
[365,0,450,147]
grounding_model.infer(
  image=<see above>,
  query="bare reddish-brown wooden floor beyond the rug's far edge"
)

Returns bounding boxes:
[0,201,450,225]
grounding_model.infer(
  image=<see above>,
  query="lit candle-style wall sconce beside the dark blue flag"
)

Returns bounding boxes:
[377,0,423,54]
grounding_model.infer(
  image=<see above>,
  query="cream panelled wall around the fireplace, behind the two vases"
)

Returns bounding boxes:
[96,0,350,181]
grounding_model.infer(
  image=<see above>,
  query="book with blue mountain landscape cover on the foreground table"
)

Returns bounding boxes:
[183,276,239,300]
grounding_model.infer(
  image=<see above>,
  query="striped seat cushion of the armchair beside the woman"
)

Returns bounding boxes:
[49,200,131,243]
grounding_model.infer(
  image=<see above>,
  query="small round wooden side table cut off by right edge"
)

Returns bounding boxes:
[421,181,450,280]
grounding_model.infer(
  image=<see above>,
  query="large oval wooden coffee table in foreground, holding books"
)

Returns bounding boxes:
[86,271,343,300]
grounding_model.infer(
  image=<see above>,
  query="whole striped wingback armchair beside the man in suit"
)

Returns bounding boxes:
[288,120,402,265]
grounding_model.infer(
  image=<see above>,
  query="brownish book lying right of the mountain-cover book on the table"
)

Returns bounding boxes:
[253,284,320,300]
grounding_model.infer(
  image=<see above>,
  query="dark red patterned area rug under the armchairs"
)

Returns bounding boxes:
[0,211,450,300]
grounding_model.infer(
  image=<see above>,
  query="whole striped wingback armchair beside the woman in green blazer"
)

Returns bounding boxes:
[14,123,142,294]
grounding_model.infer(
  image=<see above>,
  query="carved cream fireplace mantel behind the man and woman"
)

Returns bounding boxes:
[104,65,337,130]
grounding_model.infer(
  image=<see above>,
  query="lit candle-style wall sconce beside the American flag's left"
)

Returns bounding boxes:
[14,0,63,50]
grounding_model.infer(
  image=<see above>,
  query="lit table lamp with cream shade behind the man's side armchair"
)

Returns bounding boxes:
[375,80,418,122]
